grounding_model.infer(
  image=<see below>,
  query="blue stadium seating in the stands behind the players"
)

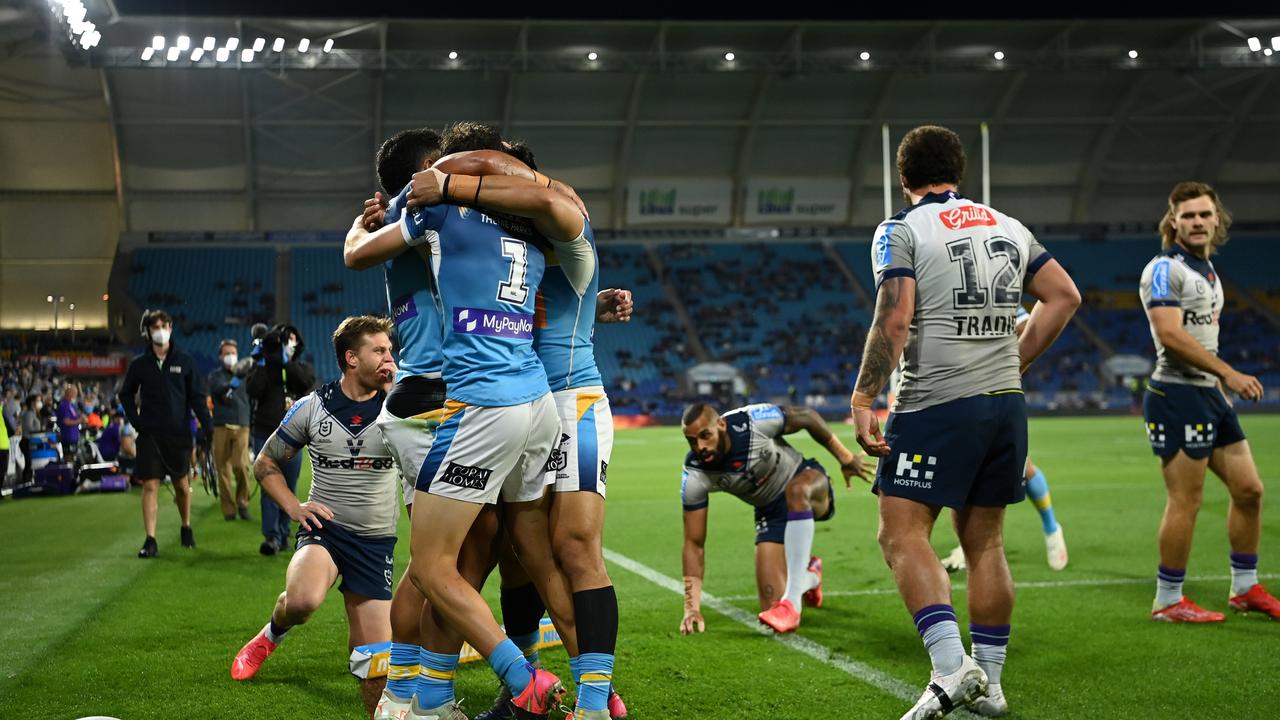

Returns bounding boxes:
[113,224,1280,425]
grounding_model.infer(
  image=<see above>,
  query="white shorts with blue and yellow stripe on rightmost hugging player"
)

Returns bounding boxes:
[547,386,613,497]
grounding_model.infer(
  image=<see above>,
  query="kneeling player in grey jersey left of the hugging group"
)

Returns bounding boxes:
[232,315,399,712]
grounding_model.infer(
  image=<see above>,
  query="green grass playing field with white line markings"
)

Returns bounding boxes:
[0,415,1280,720]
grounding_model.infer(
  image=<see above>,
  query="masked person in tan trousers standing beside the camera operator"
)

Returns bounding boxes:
[209,340,251,520]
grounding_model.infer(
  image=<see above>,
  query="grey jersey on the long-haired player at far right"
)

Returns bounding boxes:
[1138,245,1222,387]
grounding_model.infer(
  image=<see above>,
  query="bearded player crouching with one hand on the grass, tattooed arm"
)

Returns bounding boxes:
[680,402,865,634]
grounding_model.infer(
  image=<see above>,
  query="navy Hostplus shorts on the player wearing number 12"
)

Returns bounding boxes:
[872,389,1027,509]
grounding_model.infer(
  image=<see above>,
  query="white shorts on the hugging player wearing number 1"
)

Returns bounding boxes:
[417,392,559,505]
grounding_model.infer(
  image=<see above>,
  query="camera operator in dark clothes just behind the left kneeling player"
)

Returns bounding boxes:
[244,324,316,555]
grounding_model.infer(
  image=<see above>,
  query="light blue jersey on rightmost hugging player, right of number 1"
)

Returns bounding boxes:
[534,223,603,392]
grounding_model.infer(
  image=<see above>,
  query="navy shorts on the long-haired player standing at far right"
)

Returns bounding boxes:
[1142,380,1244,460]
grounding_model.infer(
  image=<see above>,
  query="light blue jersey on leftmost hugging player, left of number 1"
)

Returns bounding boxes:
[383,195,444,382]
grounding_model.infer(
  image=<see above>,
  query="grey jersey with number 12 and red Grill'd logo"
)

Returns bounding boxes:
[872,192,1051,413]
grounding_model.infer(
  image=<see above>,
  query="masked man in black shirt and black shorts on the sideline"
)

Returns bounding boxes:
[120,310,214,557]
